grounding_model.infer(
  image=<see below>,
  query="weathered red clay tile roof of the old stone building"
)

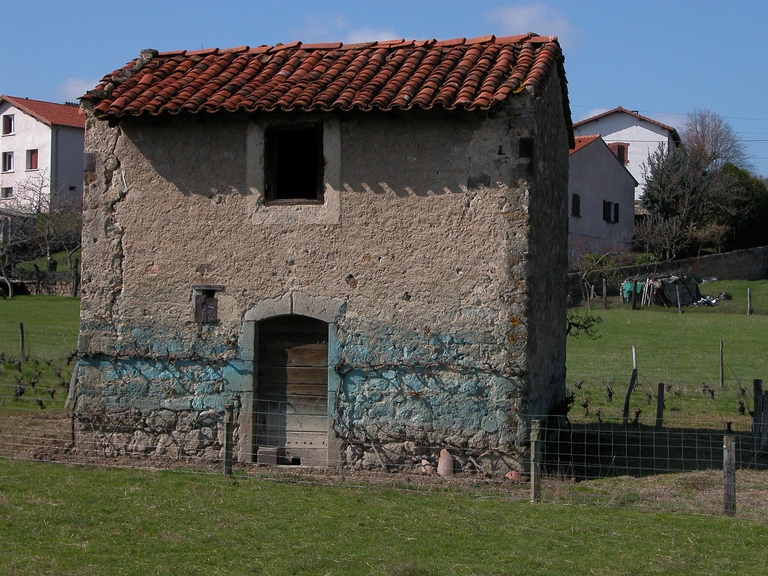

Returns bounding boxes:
[81,34,571,125]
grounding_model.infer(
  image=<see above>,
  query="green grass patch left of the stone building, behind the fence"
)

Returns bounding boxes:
[0,296,80,412]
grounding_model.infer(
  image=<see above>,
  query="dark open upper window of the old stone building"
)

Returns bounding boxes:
[264,126,323,202]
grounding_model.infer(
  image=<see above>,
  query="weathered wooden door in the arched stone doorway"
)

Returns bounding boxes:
[254,316,328,466]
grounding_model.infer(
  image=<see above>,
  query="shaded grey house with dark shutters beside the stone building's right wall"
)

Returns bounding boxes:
[568,134,637,262]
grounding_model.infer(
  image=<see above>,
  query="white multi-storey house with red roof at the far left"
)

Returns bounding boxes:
[0,95,85,211]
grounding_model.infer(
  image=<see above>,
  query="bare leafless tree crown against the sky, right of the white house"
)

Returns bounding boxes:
[680,109,751,169]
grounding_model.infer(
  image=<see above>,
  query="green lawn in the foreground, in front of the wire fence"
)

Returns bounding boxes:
[0,460,768,576]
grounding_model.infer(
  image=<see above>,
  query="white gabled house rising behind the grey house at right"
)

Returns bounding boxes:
[573,106,680,200]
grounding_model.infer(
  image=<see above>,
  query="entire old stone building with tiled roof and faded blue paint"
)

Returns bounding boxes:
[73,34,573,470]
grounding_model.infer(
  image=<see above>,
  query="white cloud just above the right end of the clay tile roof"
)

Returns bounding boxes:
[485,2,579,48]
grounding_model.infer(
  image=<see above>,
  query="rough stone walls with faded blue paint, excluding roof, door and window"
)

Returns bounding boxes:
[76,86,567,472]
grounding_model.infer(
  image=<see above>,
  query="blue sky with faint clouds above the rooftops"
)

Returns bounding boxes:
[0,0,768,176]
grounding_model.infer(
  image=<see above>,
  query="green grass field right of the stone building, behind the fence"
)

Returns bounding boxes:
[567,281,768,426]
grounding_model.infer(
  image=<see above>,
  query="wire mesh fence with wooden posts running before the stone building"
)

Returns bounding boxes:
[0,385,768,519]
